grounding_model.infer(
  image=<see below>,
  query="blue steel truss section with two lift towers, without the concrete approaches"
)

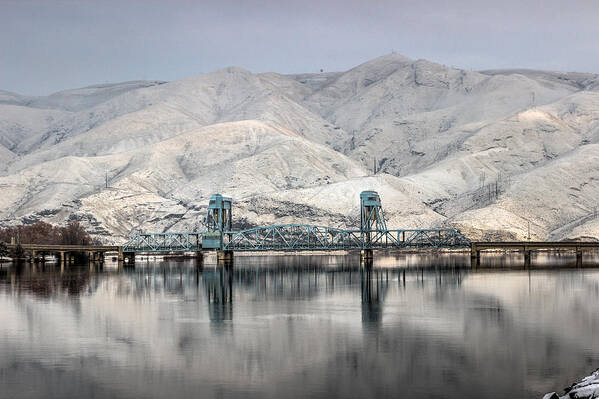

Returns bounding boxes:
[123,191,471,254]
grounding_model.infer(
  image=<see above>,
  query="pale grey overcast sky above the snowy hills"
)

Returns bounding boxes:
[0,0,599,95]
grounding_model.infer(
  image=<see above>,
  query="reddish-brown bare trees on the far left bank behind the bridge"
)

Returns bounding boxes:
[0,222,100,245]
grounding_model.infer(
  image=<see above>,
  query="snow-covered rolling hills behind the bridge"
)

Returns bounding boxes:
[0,54,599,241]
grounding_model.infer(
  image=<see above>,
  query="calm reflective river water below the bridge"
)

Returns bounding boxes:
[0,255,599,398]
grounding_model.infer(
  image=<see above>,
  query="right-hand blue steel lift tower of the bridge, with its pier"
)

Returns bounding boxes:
[360,190,387,260]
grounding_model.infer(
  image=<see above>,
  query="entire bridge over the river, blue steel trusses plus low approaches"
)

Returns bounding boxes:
[2,191,599,267]
